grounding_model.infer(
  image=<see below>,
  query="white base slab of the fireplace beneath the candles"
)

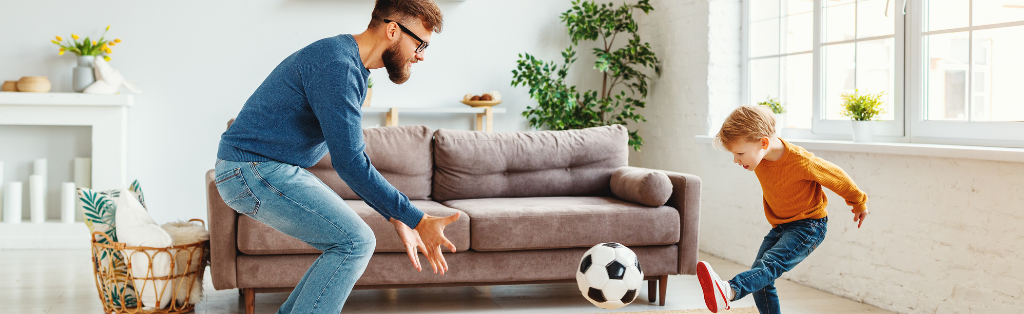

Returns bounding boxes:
[0,222,90,250]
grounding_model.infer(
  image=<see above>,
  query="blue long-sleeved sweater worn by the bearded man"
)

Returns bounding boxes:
[217,35,423,228]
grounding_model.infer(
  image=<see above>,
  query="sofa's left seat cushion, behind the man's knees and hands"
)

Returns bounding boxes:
[239,200,469,255]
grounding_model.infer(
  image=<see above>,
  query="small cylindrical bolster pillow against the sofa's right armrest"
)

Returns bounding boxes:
[611,167,672,207]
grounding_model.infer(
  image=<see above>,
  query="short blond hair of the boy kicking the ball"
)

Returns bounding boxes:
[715,105,775,148]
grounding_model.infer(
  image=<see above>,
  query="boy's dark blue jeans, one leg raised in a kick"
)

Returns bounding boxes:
[729,217,828,314]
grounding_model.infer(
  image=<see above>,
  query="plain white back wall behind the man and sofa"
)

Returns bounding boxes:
[0,0,586,222]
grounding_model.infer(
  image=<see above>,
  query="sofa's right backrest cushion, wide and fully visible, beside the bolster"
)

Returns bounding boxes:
[432,125,629,201]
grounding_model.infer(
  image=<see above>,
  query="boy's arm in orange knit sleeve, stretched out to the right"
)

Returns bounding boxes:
[809,156,868,228]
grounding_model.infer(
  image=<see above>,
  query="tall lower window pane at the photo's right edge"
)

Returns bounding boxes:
[971,25,1024,122]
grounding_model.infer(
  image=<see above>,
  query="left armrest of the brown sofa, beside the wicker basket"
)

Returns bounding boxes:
[206,170,239,290]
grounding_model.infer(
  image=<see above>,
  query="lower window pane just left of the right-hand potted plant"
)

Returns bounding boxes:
[821,43,856,120]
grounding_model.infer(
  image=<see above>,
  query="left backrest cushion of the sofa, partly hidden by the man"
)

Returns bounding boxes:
[306,126,434,199]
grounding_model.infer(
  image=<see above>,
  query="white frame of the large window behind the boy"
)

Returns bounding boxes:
[741,0,1024,147]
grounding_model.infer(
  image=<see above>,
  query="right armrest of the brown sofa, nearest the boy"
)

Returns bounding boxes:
[630,170,700,275]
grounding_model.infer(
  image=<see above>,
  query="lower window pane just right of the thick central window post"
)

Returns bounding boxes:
[924,32,970,121]
